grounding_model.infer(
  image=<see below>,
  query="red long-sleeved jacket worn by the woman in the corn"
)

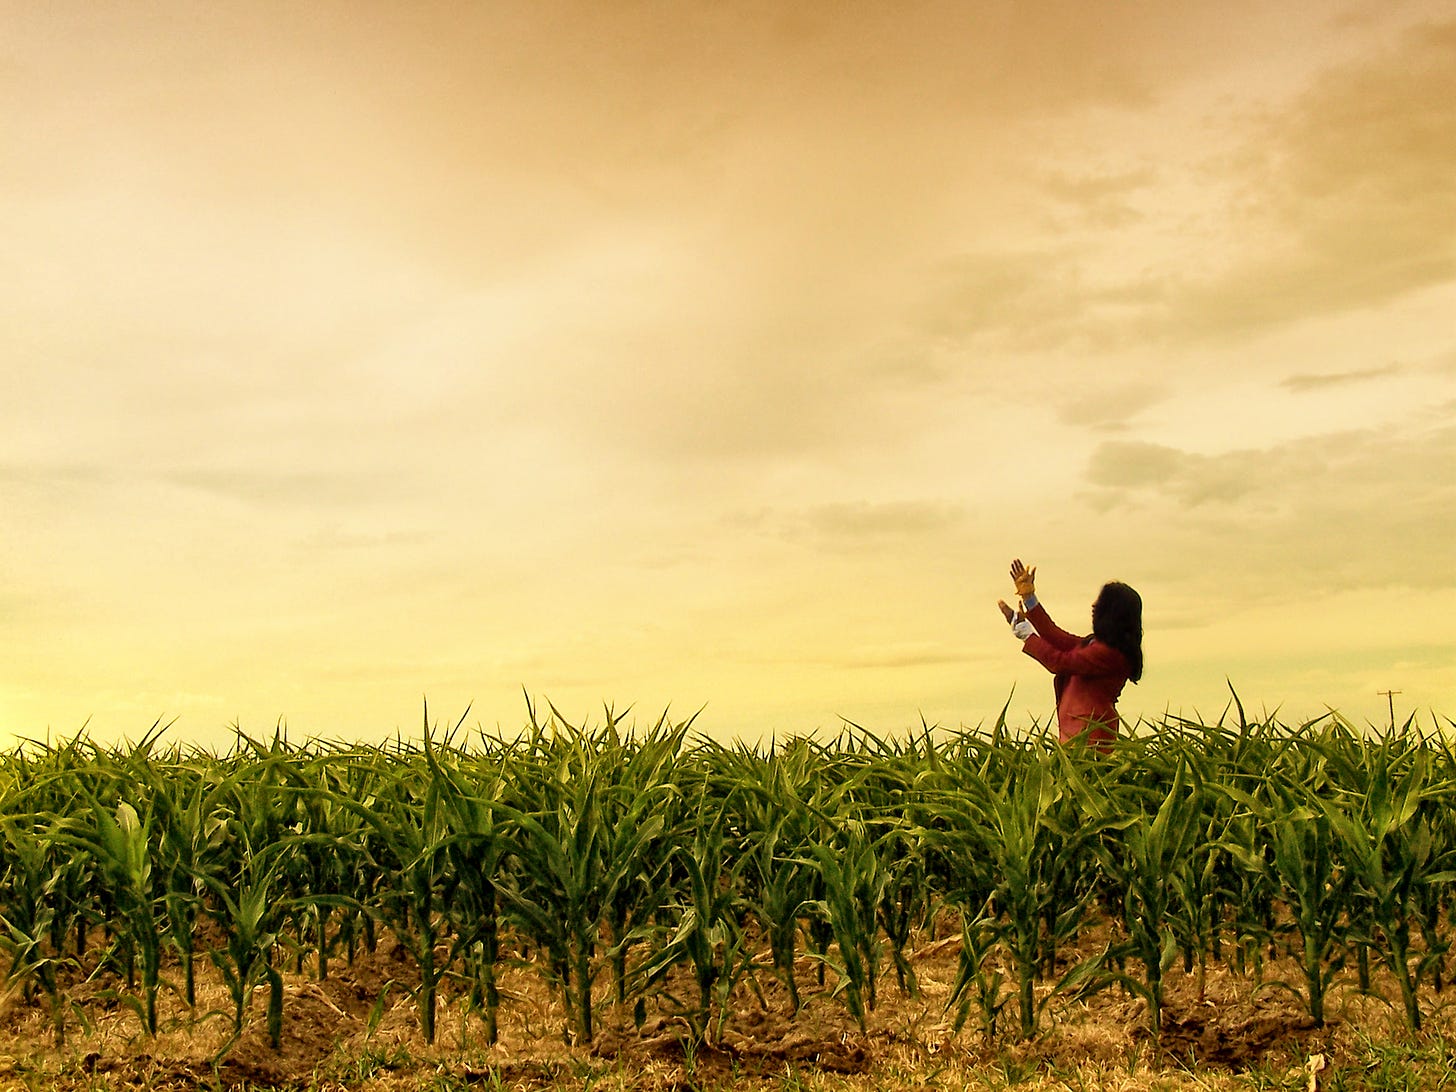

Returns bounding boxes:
[1021,603,1130,750]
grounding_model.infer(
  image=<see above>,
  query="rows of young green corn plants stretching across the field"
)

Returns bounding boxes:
[0,709,1456,1057]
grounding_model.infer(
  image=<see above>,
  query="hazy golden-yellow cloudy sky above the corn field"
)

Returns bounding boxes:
[0,0,1456,747]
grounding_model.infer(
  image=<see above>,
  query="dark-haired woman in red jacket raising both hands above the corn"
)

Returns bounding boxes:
[997,558,1143,751]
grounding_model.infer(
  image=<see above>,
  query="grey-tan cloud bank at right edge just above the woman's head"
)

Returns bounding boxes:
[1083,425,1456,598]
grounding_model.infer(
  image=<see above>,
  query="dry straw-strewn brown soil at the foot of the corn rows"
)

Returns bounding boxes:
[0,936,1456,1092]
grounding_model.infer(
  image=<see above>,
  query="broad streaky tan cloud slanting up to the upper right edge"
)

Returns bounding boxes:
[949,14,1456,352]
